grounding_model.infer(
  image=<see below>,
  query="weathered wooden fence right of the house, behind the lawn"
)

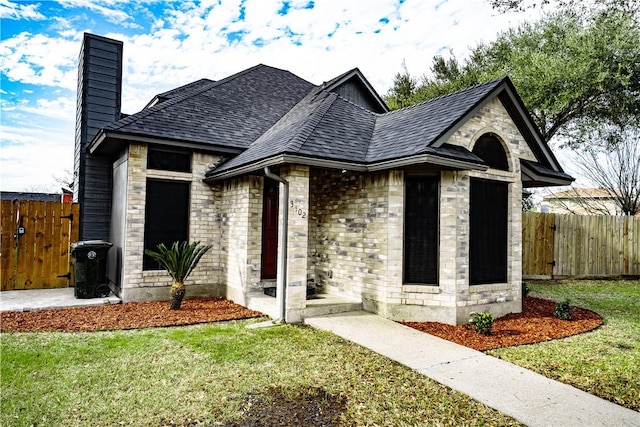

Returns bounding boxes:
[522,212,640,278]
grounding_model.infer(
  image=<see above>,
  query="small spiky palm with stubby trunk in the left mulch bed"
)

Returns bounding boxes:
[144,242,211,310]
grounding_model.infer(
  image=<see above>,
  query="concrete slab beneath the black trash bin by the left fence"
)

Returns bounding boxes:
[0,288,122,311]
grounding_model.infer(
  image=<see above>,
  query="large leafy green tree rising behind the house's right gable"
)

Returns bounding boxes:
[388,11,640,146]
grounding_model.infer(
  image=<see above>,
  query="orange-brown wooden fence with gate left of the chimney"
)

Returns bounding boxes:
[0,200,80,291]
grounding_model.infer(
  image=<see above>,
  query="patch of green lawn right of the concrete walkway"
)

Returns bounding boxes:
[487,280,640,411]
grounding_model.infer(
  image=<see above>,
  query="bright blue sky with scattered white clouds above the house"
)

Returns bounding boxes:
[0,0,531,191]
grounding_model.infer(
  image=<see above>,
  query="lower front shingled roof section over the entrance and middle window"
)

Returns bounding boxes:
[207,79,516,177]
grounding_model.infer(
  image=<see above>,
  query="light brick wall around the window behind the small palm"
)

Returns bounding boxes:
[117,143,222,301]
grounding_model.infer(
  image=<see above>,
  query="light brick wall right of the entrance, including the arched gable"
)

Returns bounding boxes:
[308,99,535,324]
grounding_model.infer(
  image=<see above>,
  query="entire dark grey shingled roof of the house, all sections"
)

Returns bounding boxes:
[90,65,571,185]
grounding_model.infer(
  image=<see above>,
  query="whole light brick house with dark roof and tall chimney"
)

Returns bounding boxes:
[76,34,572,324]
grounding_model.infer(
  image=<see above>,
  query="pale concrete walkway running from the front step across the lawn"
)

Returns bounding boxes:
[305,311,640,427]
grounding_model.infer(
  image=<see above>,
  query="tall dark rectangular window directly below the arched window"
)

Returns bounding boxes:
[469,179,509,285]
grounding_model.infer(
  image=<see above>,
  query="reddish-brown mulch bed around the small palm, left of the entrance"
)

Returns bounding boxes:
[0,298,263,332]
